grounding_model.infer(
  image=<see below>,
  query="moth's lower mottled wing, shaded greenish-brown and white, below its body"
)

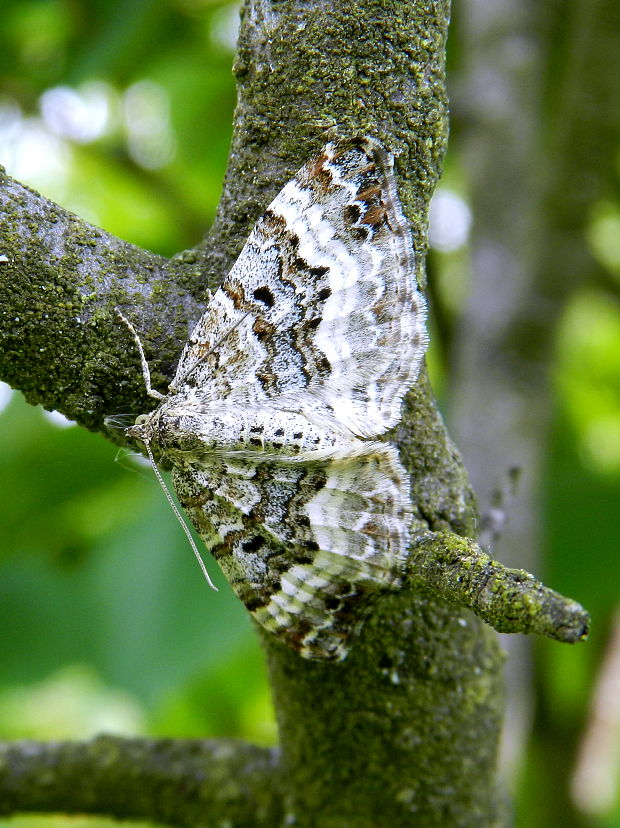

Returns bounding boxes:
[173,443,411,661]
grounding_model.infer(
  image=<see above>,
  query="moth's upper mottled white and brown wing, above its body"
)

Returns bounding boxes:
[172,138,427,436]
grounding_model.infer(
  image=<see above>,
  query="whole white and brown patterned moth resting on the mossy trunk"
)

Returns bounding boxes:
[128,138,427,661]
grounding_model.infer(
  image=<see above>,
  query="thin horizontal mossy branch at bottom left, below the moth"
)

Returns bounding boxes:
[0,736,283,828]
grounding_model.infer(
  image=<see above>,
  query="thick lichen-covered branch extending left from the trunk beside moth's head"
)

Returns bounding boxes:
[0,171,203,440]
